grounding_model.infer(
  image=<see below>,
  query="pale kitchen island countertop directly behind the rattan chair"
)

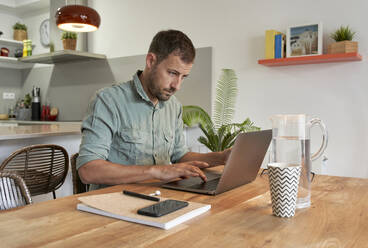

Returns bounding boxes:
[0,123,81,140]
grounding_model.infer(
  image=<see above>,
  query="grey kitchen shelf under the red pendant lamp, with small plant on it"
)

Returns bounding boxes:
[19,50,106,64]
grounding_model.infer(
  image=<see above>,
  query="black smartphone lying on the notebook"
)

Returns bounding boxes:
[138,200,189,217]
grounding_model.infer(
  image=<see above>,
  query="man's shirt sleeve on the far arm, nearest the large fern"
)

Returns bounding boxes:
[171,105,189,163]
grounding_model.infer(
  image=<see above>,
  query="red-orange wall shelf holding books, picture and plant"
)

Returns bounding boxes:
[258,53,362,66]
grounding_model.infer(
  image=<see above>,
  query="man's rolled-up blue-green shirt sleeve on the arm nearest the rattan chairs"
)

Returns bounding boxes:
[77,92,116,169]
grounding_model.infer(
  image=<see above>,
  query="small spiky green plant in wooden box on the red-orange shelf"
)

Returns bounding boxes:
[327,26,358,54]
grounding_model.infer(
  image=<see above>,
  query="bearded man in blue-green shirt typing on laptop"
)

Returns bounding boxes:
[77,30,230,189]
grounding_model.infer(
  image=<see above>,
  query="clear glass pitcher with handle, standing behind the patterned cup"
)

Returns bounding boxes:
[270,114,328,208]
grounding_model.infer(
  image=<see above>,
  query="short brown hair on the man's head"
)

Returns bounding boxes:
[148,29,195,64]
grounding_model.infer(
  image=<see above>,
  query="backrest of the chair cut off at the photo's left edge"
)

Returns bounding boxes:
[0,172,32,210]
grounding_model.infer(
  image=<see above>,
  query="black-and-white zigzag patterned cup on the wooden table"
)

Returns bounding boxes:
[267,163,301,217]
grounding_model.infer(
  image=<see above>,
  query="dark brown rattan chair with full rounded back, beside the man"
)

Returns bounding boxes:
[0,144,69,199]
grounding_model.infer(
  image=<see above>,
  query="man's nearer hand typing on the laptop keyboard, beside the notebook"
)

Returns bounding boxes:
[151,161,209,181]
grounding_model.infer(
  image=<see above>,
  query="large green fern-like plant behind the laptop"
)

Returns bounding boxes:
[183,69,260,152]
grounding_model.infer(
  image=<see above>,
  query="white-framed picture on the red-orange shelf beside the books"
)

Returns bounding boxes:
[286,23,322,57]
